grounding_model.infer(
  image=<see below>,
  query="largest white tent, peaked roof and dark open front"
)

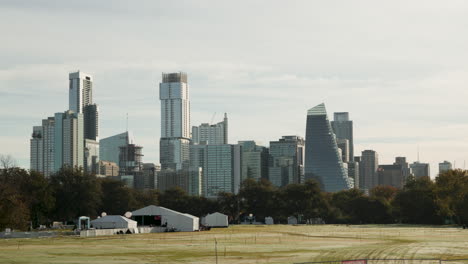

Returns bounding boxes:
[132,205,200,232]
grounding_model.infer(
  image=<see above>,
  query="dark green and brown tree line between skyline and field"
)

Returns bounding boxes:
[0,167,468,230]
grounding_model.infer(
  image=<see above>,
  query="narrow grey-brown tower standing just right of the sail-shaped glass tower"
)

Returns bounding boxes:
[359,150,379,190]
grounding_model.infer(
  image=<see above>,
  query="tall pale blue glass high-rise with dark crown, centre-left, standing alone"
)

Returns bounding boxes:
[159,72,190,170]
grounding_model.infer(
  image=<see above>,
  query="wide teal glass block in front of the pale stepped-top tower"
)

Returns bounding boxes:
[202,144,242,198]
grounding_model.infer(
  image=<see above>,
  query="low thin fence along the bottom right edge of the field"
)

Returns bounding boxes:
[295,259,468,264]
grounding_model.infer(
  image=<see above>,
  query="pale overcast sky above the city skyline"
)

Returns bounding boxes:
[0,0,468,175]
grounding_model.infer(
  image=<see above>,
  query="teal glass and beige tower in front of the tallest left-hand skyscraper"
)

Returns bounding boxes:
[54,110,84,171]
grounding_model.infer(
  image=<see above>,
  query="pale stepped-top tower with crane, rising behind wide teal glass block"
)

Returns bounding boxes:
[192,113,228,145]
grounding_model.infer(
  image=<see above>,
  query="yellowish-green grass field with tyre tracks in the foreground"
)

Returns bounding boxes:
[0,225,468,264]
